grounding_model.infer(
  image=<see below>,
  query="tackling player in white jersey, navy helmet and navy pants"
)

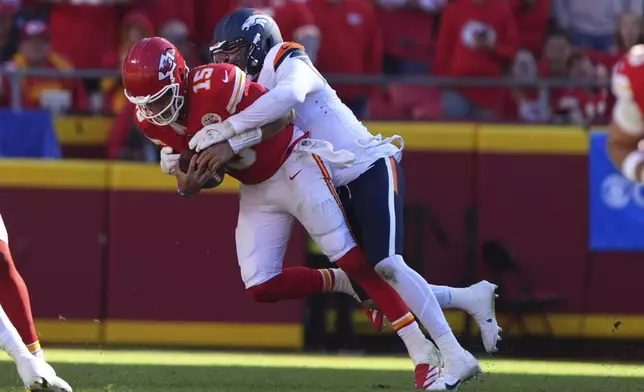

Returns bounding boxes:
[190,9,500,390]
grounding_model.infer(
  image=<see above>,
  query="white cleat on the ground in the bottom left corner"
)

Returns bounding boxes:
[16,355,72,392]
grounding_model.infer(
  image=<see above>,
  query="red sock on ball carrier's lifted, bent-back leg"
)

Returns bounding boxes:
[246,267,335,302]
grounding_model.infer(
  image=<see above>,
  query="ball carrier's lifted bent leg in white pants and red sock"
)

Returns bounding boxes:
[235,185,355,302]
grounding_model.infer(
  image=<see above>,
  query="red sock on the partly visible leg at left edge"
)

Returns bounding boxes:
[0,241,40,353]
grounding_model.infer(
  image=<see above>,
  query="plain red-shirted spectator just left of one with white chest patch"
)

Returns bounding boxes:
[376,0,446,75]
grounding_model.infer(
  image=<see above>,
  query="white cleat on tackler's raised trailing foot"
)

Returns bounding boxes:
[463,280,501,354]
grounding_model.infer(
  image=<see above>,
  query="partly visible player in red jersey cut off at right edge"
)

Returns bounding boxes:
[607,45,644,183]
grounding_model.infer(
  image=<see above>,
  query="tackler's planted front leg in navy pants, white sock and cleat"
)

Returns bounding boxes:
[341,158,479,390]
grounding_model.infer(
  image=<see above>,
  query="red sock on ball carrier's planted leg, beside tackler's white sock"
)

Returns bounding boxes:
[336,247,414,329]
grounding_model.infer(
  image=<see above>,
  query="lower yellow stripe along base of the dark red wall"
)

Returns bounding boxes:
[36,311,644,349]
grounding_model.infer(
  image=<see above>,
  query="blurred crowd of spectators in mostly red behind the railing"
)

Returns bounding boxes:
[0,0,644,156]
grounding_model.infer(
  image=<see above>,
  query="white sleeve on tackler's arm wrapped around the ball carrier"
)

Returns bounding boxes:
[227,58,325,133]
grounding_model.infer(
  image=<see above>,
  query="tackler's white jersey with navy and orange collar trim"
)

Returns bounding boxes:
[228,42,400,187]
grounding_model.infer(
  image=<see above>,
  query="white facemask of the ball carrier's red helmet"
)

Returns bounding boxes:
[125,83,184,126]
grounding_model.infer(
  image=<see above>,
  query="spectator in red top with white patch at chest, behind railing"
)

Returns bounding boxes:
[435,0,518,119]
